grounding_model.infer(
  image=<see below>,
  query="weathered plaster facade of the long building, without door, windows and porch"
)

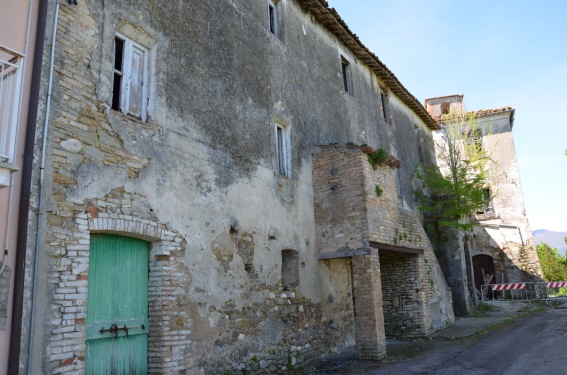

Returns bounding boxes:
[23,0,450,374]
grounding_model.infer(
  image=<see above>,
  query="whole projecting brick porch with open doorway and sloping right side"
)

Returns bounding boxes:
[313,145,453,347]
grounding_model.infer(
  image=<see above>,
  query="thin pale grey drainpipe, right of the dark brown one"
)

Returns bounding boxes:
[26,0,59,375]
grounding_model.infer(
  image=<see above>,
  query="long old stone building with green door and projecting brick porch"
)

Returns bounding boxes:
[13,0,454,374]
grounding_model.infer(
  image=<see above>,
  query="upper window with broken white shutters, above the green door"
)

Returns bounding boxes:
[112,33,150,121]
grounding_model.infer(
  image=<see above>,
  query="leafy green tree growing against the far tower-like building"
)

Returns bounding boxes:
[414,111,495,238]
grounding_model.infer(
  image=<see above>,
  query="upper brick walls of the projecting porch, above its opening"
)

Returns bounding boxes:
[313,145,431,252]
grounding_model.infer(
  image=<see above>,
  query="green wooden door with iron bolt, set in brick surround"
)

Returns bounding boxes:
[86,234,149,375]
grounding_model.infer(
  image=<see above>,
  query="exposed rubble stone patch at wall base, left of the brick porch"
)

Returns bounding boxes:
[203,259,354,374]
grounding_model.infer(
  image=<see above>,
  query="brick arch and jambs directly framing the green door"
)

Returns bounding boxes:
[67,209,191,373]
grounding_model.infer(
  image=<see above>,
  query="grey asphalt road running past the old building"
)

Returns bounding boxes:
[313,309,567,375]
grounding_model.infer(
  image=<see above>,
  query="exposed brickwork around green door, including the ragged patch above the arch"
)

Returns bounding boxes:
[41,189,191,373]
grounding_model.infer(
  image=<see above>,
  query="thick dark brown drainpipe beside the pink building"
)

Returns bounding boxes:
[8,0,48,375]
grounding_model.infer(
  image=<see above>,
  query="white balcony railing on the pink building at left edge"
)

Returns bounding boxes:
[0,45,24,164]
